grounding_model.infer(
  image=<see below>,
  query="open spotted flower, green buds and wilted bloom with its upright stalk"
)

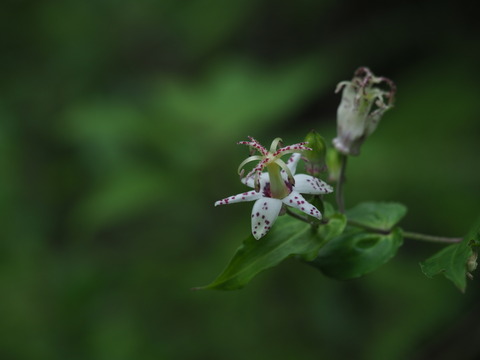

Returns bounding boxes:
[215,67,396,240]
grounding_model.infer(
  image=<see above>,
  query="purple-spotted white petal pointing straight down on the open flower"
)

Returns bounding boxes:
[252,197,282,240]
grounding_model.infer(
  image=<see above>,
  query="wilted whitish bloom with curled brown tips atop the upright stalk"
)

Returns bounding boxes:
[333,67,396,155]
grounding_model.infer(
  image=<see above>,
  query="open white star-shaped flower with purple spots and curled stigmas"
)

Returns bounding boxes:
[215,138,333,240]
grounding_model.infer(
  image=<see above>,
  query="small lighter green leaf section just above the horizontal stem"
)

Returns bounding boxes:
[347,202,407,231]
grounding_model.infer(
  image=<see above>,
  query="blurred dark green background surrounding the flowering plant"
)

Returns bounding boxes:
[0,0,480,360]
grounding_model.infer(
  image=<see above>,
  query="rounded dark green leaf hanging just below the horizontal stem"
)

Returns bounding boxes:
[310,228,403,280]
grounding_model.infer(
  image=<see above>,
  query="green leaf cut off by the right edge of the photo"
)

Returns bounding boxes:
[420,218,480,292]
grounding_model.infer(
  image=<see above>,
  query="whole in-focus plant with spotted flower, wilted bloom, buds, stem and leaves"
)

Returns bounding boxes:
[204,67,480,291]
